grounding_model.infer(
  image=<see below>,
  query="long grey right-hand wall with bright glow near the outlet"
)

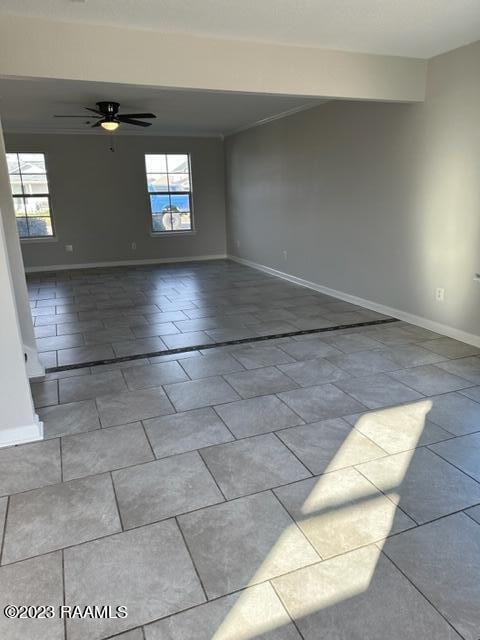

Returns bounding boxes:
[226,38,480,336]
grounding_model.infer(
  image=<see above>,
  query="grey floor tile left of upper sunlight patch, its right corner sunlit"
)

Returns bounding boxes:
[277,418,385,475]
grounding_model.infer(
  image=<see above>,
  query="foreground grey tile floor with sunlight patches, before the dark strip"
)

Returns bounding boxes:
[0,263,480,640]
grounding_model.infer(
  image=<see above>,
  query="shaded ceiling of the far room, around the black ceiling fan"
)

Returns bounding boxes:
[0,78,321,135]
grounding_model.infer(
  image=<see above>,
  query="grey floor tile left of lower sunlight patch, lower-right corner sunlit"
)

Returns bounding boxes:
[178,492,318,598]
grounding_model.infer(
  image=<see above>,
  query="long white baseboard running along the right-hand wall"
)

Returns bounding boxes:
[228,255,480,348]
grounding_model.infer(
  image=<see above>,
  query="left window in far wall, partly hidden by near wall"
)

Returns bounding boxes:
[7,153,53,238]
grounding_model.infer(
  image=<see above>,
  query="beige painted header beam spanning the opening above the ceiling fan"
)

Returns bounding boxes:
[0,15,427,101]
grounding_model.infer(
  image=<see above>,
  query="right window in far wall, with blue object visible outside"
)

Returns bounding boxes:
[145,153,193,233]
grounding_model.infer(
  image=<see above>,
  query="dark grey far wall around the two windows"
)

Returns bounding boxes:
[5,133,225,267]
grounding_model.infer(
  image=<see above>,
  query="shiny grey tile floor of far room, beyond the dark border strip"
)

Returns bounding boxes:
[28,260,386,368]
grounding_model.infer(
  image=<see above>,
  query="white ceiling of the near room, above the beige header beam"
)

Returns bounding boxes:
[0,0,480,58]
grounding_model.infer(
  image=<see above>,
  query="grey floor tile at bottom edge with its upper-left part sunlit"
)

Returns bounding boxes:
[273,534,460,640]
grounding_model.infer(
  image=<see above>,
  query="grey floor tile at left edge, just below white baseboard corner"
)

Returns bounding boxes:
[0,440,61,495]
